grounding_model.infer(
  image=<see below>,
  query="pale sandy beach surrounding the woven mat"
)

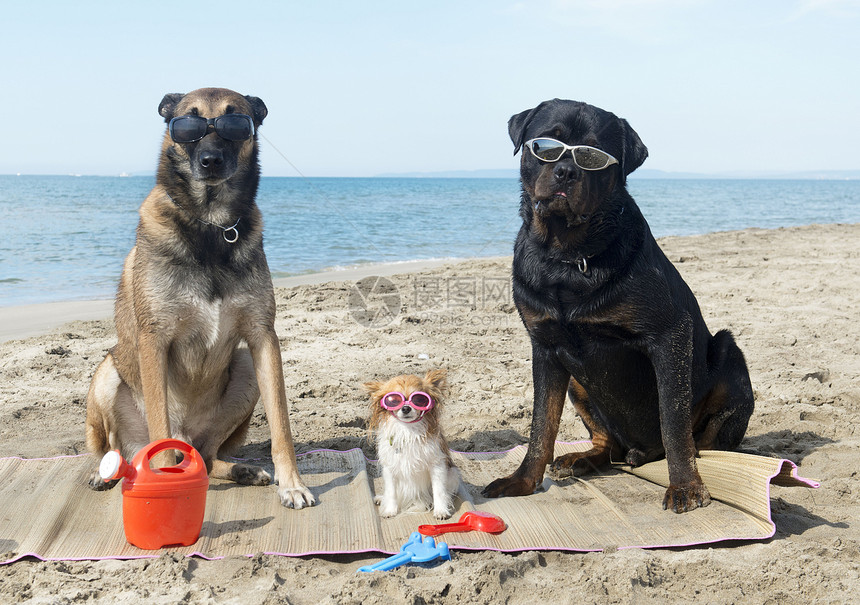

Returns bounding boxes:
[0,224,860,605]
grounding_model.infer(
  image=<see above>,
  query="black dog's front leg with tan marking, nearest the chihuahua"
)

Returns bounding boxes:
[482,344,570,498]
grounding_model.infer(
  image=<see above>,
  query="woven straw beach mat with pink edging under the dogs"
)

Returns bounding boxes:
[0,442,818,563]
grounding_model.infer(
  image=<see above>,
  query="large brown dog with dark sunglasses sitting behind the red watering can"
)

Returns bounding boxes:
[87,88,314,508]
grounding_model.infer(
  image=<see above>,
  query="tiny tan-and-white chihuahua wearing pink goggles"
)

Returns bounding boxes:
[364,370,460,519]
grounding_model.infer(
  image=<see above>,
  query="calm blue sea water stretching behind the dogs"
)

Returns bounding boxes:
[0,176,860,306]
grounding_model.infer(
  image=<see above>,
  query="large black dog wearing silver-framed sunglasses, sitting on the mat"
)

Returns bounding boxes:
[484,99,754,512]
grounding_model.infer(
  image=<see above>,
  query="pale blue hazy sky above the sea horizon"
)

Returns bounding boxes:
[0,0,860,176]
